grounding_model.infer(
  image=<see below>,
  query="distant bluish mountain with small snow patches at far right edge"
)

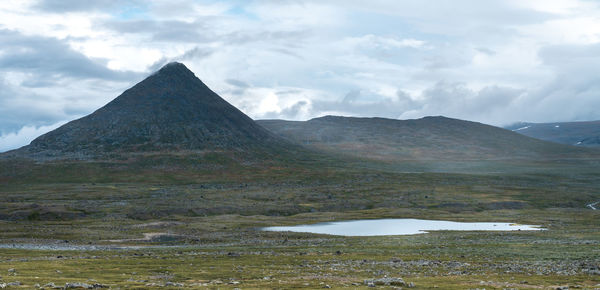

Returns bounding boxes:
[506,121,600,147]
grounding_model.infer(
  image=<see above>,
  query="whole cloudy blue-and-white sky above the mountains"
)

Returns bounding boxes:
[0,0,600,152]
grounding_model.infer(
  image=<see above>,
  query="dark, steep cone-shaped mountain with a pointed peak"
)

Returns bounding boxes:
[11,63,286,156]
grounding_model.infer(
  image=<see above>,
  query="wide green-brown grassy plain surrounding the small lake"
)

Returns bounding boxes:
[0,154,600,289]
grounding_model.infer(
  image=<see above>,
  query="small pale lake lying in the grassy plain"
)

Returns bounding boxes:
[262,219,543,236]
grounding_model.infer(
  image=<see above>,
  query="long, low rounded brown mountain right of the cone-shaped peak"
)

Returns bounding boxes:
[257,116,595,160]
